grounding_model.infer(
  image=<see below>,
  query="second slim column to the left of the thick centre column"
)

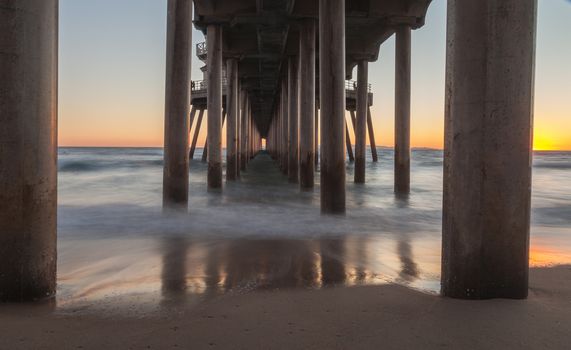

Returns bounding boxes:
[288,57,299,183]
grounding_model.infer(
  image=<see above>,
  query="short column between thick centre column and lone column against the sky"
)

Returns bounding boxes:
[355,60,369,183]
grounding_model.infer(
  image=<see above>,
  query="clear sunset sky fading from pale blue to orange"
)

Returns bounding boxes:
[59,0,571,150]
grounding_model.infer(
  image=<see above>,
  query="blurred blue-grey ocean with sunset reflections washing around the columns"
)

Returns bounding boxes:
[57,148,571,312]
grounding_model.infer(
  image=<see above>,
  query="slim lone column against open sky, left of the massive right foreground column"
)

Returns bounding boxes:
[395,26,411,194]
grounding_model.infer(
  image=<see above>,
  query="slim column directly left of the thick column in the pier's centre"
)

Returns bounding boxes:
[298,19,317,190]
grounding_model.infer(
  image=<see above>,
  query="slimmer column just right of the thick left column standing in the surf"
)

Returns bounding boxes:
[206,24,222,189]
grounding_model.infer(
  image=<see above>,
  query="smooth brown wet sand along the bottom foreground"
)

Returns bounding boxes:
[0,266,571,349]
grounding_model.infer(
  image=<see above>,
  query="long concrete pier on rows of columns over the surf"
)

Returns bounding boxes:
[0,0,537,302]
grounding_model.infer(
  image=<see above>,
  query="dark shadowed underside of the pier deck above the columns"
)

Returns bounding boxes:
[194,0,431,137]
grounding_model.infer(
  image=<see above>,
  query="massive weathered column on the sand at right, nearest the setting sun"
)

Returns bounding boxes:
[442,0,537,299]
